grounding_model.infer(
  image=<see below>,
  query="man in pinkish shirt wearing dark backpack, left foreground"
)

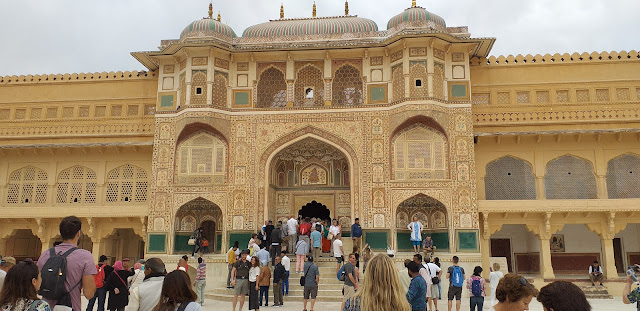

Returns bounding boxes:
[38,216,98,310]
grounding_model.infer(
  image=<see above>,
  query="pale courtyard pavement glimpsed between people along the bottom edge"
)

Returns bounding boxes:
[77,298,635,311]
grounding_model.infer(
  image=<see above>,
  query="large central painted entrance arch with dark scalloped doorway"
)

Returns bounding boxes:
[267,137,352,231]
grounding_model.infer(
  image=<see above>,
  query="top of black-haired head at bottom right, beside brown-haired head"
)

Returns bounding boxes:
[538,281,591,311]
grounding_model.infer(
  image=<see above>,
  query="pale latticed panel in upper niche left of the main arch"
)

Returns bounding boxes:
[177,132,227,184]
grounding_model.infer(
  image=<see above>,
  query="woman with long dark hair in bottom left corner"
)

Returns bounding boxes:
[0,260,51,311]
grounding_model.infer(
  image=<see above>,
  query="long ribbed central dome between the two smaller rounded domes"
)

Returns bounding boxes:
[242,16,378,38]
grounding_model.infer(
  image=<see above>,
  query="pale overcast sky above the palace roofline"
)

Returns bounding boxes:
[0,0,640,75]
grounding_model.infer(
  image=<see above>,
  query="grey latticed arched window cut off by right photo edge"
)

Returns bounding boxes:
[607,154,640,199]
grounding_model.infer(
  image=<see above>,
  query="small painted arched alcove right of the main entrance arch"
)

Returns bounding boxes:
[396,194,449,251]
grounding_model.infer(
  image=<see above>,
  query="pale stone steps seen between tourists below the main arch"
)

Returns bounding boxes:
[206,258,348,303]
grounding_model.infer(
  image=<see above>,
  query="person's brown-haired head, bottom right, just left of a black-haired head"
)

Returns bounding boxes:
[493,274,538,311]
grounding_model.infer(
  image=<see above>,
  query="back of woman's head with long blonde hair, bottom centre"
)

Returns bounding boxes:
[343,254,411,311]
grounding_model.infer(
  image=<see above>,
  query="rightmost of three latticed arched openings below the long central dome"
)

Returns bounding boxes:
[331,65,363,106]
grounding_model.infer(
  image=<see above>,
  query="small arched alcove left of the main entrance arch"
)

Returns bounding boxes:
[173,198,222,254]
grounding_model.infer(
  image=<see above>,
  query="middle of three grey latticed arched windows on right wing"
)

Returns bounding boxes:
[544,155,598,200]
